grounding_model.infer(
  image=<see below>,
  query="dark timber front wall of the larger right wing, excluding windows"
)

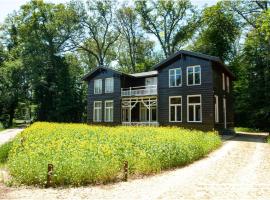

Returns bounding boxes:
[158,56,214,130]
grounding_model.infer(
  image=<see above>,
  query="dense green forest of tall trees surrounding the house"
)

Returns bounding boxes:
[0,0,270,130]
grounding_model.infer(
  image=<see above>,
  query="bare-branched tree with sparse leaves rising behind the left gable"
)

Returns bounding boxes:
[73,0,120,67]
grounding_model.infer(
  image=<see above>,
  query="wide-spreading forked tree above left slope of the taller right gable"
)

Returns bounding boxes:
[136,0,198,57]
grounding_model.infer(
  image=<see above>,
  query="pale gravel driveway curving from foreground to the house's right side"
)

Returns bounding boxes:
[0,134,270,200]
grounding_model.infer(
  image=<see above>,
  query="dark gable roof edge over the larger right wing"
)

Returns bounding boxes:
[153,50,235,78]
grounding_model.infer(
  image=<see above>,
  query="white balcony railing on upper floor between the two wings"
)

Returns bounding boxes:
[121,85,157,97]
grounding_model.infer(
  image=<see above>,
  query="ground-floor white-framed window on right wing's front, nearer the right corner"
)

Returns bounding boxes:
[187,95,202,122]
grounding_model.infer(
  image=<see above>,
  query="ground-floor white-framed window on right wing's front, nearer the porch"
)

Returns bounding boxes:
[169,96,182,122]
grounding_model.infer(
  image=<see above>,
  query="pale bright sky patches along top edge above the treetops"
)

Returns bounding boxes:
[0,0,218,23]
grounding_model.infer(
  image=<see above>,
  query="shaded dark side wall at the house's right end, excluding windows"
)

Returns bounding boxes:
[212,63,234,130]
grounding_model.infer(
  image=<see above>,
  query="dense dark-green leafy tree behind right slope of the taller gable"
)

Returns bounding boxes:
[191,2,240,61]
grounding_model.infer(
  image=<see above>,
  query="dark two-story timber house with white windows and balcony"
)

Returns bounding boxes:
[83,50,234,130]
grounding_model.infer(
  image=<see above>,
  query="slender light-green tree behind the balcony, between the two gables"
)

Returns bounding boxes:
[117,6,154,73]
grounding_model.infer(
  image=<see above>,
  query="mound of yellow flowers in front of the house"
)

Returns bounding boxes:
[8,122,221,186]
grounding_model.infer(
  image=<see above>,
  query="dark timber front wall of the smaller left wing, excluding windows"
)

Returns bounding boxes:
[87,70,121,125]
